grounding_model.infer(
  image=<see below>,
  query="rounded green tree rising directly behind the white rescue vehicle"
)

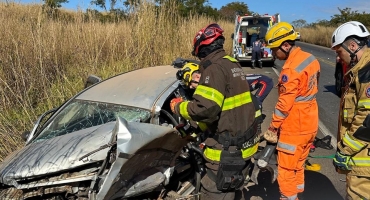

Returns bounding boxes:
[219,1,252,21]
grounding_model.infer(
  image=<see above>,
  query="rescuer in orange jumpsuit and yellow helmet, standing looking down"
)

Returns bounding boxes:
[263,22,320,200]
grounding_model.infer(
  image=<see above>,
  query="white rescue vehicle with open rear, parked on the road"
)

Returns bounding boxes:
[231,14,280,62]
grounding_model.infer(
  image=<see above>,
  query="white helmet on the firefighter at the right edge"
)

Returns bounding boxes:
[331,21,370,48]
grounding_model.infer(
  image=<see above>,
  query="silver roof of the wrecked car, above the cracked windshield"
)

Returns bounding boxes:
[76,65,178,110]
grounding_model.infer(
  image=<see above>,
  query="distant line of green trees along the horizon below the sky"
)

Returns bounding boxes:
[43,0,370,28]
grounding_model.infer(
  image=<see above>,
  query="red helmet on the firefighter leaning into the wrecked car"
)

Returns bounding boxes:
[191,23,224,56]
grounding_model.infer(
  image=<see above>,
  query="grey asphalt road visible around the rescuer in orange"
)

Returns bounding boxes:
[242,42,345,200]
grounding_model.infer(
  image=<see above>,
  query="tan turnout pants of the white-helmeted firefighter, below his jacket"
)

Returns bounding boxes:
[346,175,370,200]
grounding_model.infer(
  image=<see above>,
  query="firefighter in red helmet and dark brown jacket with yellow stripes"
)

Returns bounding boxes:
[170,23,259,200]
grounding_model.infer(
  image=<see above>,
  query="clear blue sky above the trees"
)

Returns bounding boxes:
[21,0,370,23]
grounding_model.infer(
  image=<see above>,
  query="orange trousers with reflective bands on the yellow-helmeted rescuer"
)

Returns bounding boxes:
[277,132,317,200]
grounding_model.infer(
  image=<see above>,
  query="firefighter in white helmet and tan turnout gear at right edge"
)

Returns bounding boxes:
[331,21,370,200]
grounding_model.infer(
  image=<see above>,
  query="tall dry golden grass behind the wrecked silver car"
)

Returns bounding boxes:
[0,3,234,161]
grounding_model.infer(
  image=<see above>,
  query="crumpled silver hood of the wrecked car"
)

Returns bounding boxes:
[0,122,115,185]
